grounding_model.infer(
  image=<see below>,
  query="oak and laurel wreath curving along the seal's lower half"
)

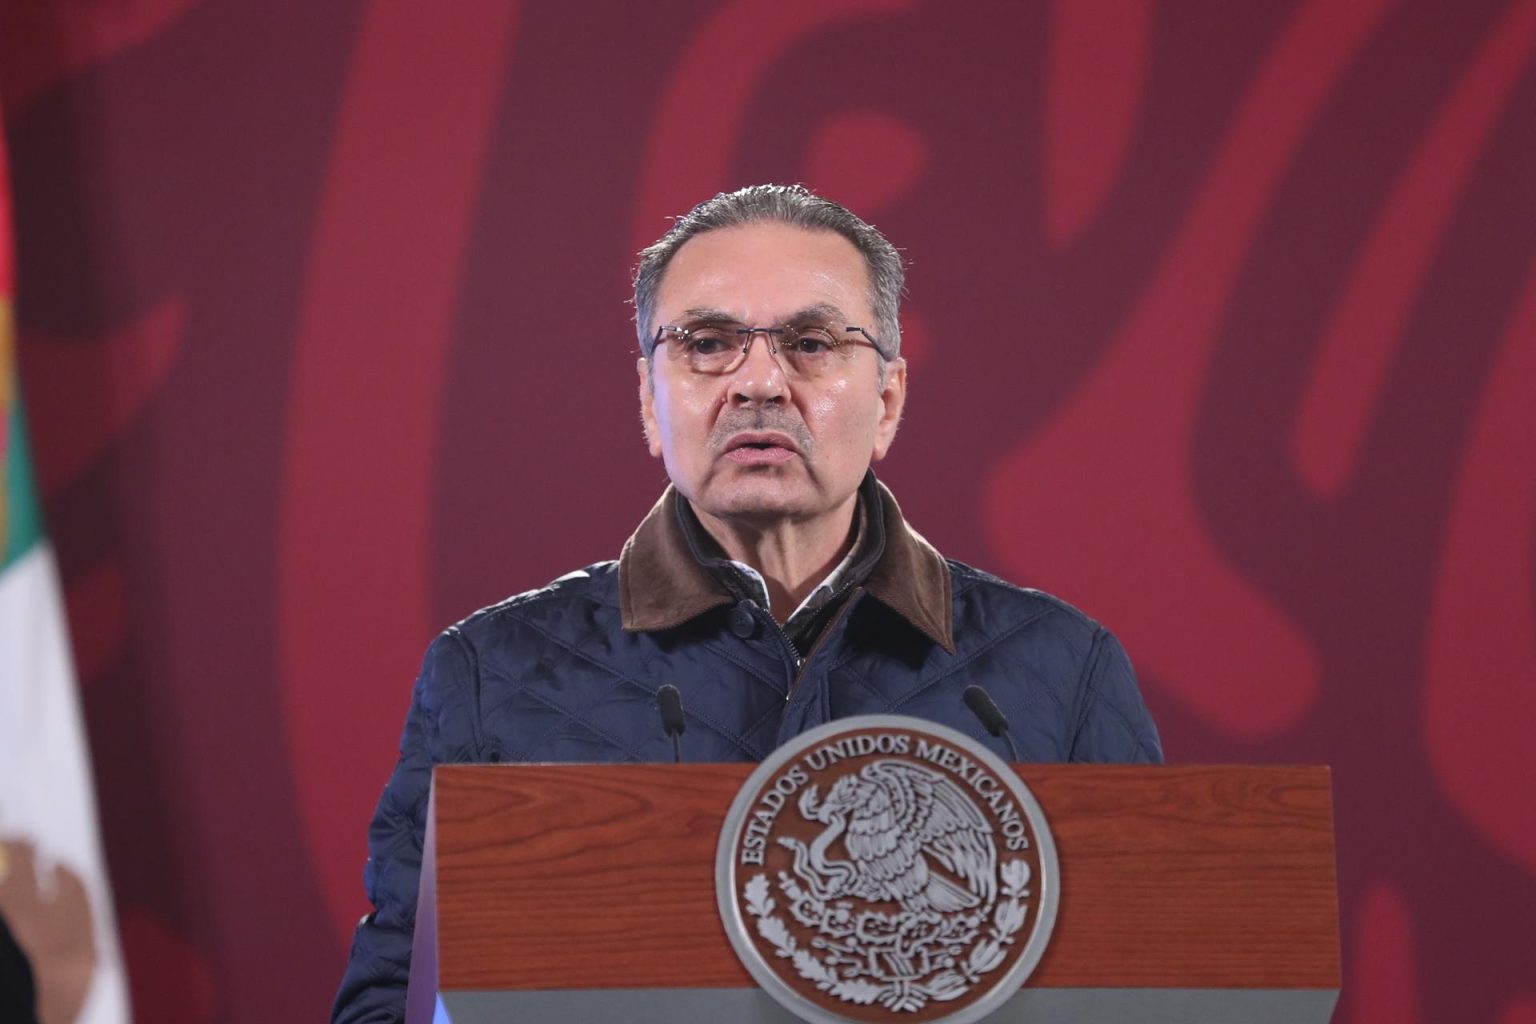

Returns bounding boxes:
[742,860,1029,1012]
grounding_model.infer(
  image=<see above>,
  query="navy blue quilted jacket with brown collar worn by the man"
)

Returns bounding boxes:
[333,477,1163,1024]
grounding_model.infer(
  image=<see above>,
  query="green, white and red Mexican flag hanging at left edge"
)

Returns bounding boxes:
[0,115,129,1024]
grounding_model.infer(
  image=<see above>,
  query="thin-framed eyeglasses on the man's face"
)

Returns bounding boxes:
[654,322,885,381]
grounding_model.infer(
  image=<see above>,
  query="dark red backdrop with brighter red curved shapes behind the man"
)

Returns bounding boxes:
[0,0,1536,1024]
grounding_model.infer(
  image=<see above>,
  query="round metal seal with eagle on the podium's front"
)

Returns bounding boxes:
[716,715,1060,1024]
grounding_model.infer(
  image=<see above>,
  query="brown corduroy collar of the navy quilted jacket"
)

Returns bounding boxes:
[619,481,955,654]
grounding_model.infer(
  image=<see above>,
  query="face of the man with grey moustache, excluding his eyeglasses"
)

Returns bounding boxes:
[639,223,906,527]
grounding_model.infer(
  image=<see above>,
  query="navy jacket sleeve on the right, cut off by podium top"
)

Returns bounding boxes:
[1068,628,1163,765]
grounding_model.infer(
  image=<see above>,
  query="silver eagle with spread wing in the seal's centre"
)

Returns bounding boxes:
[779,760,997,913]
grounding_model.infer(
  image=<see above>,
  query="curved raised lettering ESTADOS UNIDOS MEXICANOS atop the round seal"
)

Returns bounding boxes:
[740,732,1029,866]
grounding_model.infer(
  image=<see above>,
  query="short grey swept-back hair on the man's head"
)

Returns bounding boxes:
[634,184,906,360]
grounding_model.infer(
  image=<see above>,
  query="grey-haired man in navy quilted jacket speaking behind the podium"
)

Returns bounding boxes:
[333,186,1161,1022]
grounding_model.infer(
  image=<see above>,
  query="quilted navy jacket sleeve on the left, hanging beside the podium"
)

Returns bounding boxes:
[330,629,475,1024]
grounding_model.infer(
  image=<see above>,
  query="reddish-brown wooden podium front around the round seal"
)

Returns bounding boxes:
[407,765,1339,1024]
